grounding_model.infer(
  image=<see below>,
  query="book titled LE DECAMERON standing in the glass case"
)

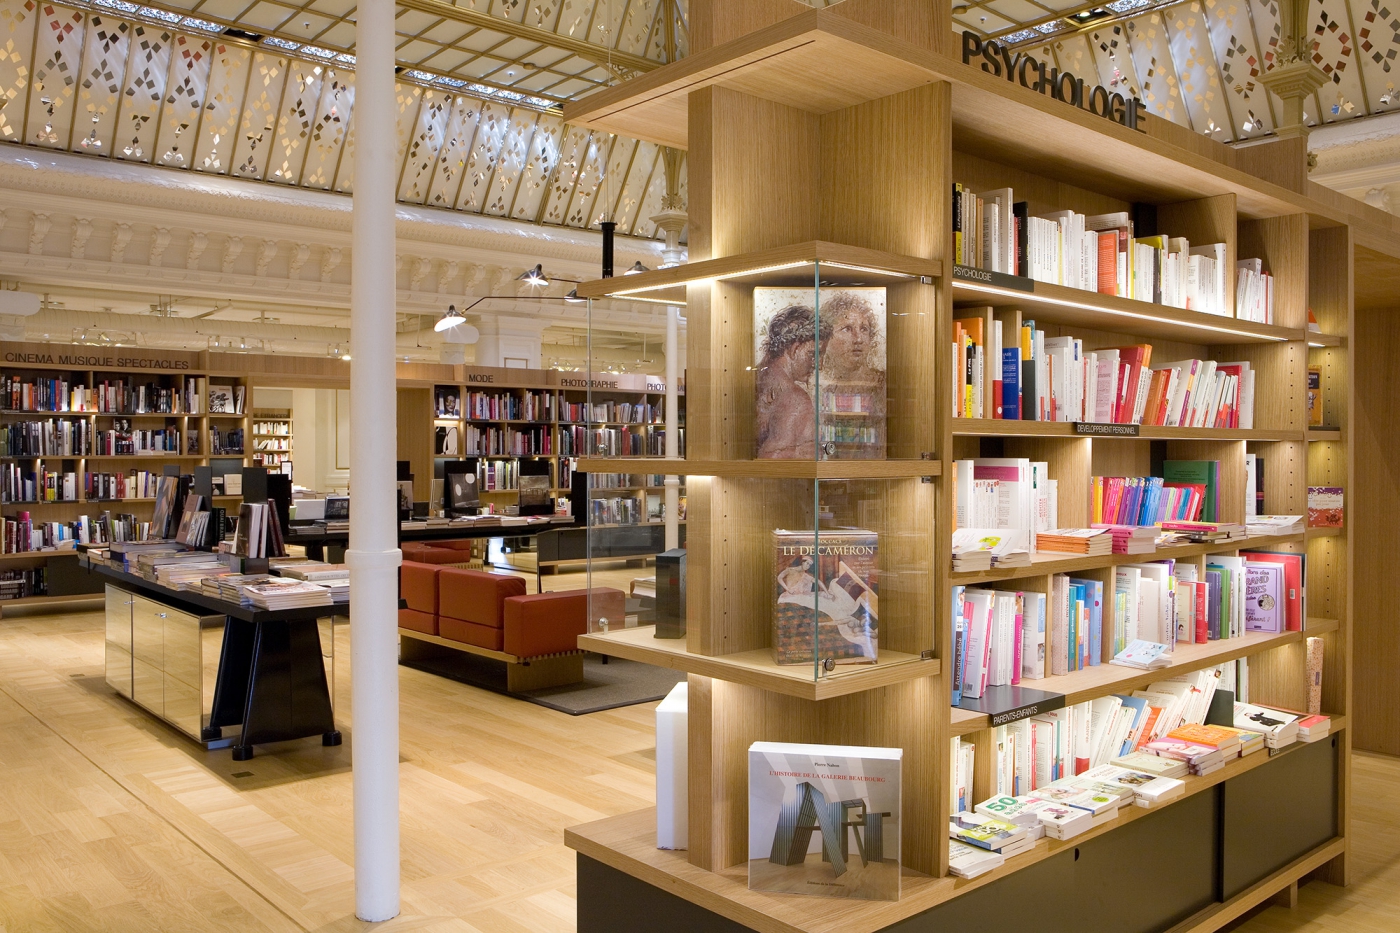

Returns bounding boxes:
[773,528,879,664]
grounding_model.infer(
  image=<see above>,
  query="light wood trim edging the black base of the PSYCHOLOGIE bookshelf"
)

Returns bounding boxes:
[564,740,1347,933]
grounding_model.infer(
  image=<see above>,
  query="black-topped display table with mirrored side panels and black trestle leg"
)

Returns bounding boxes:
[85,559,341,761]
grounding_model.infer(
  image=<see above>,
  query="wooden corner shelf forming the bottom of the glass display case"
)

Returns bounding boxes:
[578,625,942,700]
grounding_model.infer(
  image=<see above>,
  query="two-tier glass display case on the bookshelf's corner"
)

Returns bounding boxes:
[582,254,937,680]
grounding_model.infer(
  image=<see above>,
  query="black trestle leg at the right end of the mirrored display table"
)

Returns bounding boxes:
[234,619,340,761]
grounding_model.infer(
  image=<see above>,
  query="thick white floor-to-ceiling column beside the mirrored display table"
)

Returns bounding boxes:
[346,0,402,922]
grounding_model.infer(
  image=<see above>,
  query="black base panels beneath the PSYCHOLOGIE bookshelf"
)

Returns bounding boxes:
[578,735,1341,933]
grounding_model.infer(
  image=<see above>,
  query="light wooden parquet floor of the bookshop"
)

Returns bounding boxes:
[0,570,1400,933]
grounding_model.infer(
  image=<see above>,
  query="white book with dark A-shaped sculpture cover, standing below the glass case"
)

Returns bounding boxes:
[749,742,904,901]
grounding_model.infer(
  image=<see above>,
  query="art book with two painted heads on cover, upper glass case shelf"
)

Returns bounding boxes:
[753,287,886,459]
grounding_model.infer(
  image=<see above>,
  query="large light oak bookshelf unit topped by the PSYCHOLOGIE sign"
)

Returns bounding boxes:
[566,0,1366,933]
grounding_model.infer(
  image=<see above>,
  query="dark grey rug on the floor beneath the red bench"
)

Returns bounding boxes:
[403,651,686,716]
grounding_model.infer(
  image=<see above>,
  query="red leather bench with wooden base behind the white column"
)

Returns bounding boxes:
[399,560,626,692]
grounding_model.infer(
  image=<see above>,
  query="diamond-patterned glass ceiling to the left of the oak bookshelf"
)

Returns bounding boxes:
[0,0,686,237]
